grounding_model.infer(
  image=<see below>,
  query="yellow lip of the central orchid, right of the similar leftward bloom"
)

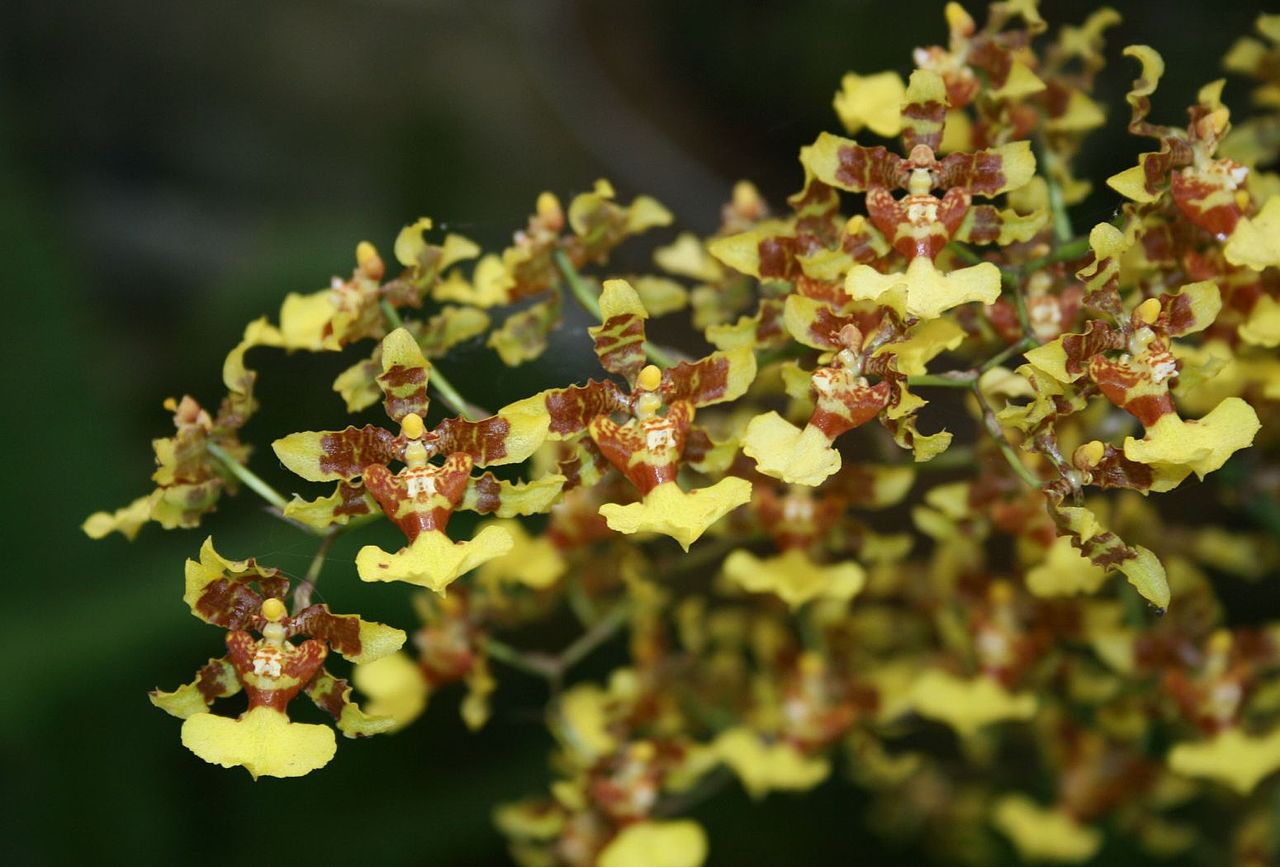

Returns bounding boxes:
[600,476,751,551]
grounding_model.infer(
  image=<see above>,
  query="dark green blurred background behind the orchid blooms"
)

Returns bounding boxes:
[0,0,1258,864]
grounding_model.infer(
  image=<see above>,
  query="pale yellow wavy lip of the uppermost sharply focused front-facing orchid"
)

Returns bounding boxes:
[845,256,1000,319]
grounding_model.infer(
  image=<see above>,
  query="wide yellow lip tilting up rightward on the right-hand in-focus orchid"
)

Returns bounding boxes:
[1124,397,1262,478]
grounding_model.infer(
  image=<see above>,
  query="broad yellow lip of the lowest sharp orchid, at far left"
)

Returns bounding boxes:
[182,707,338,780]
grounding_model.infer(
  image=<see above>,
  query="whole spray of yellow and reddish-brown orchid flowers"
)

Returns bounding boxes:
[84,0,1280,867]
